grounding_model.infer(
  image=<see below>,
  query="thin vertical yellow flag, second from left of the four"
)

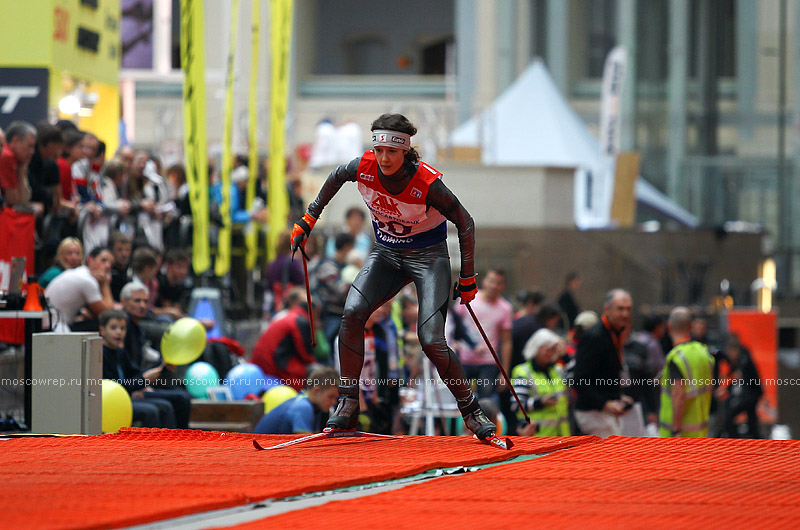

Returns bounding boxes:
[214,0,239,276]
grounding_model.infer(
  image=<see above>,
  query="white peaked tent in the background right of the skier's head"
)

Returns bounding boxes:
[450,59,698,227]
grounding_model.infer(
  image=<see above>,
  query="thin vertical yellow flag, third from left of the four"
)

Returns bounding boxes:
[244,0,261,270]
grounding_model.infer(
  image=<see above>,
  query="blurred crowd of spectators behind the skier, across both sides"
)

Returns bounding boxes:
[0,121,762,437]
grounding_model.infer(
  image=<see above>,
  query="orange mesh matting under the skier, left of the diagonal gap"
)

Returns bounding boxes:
[0,429,597,529]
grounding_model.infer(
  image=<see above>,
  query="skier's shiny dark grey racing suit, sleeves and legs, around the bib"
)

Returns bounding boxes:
[308,157,478,415]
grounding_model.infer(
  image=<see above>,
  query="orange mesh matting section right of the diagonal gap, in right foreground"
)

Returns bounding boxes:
[232,437,800,530]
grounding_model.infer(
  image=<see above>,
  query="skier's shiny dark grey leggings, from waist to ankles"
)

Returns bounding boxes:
[339,241,477,414]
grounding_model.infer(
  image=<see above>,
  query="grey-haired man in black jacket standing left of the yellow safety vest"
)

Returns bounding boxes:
[575,289,633,437]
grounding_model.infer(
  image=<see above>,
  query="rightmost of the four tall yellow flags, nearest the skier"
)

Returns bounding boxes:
[267,0,294,260]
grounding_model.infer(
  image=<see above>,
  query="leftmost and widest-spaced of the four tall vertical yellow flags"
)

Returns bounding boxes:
[181,0,211,274]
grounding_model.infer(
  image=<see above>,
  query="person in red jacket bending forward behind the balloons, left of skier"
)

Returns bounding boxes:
[250,287,316,391]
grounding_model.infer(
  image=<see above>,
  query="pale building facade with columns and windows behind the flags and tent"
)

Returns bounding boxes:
[121,0,800,296]
